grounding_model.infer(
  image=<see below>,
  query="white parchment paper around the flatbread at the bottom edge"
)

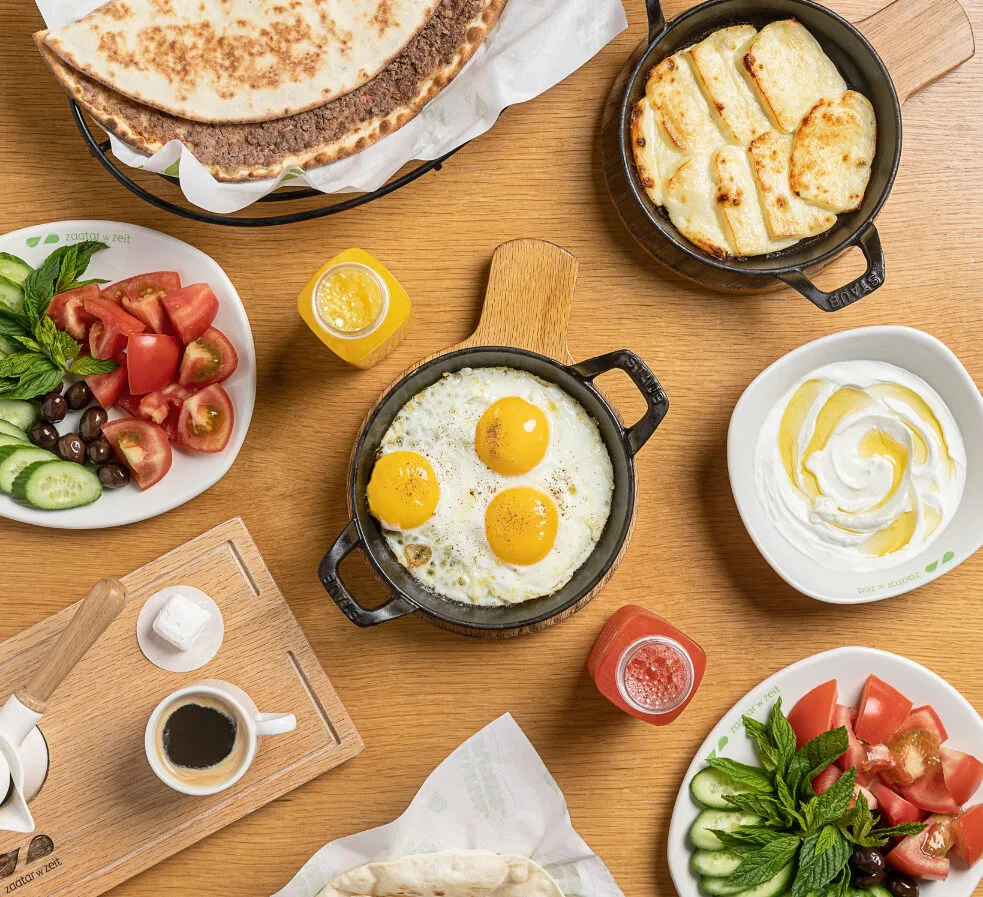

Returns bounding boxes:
[274,714,624,897]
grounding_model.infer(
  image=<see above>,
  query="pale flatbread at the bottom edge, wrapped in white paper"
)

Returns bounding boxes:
[317,850,564,897]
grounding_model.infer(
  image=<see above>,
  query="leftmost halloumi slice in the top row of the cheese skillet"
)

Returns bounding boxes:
[645,50,726,156]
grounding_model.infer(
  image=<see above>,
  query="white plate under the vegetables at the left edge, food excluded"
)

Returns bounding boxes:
[0,221,256,529]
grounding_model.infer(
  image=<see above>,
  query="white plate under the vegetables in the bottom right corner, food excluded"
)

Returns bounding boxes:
[668,647,983,897]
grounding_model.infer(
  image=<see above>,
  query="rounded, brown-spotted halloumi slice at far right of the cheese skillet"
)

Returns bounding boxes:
[789,90,877,212]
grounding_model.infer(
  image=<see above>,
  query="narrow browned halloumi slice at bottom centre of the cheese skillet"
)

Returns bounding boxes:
[713,146,795,255]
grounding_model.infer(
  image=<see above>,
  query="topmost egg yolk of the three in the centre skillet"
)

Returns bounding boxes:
[474,396,550,476]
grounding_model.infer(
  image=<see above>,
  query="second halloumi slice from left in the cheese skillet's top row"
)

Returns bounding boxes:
[689,25,771,146]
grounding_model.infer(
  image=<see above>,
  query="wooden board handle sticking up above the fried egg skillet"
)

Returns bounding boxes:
[454,239,579,360]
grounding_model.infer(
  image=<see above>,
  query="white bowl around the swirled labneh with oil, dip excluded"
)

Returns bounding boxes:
[727,327,983,604]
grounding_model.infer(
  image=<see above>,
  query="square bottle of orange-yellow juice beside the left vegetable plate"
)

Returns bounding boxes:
[297,249,412,368]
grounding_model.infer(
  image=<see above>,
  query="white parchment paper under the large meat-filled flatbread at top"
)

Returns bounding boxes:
[37,0,628,213]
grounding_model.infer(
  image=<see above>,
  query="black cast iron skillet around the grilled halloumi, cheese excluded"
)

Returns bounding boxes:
[604,0,901,311]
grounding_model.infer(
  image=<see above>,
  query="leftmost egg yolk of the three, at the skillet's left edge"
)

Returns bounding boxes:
[366,452,440,530]
